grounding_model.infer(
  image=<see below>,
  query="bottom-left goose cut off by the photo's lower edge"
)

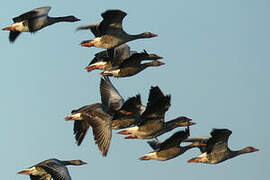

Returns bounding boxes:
[18,159,87,180]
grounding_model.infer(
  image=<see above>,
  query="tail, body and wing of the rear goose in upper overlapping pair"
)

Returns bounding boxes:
[85,44,136,72]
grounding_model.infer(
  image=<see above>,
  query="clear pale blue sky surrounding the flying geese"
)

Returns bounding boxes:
[0,0,270,180]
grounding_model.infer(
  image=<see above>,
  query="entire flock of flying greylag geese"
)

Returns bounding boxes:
[3,7,258,180]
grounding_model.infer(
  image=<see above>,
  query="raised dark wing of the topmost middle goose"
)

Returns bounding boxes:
[99,10,127,35]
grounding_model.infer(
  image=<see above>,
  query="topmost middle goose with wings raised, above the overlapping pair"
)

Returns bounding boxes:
[77,10,157,52]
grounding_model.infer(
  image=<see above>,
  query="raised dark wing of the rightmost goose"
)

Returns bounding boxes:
[206,129,232,154]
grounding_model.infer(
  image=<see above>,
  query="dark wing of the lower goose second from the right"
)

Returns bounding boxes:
[160,128,190,150]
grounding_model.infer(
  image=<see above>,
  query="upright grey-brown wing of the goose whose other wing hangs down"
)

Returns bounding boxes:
[100,78,124,110]
